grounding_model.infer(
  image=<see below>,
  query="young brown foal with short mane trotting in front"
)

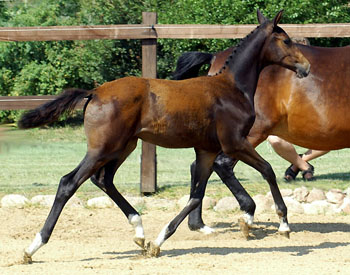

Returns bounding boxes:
[18,11,310,262]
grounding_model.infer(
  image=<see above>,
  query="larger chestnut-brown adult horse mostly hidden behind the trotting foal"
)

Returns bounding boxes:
[174,26,350,235]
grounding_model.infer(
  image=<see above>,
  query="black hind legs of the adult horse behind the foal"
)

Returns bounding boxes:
[188,153,256,237]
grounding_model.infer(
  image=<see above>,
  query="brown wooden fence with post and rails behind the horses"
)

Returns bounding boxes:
[0,12,350,193]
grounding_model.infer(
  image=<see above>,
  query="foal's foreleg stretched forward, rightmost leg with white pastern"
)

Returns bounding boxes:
[224,139,290,237]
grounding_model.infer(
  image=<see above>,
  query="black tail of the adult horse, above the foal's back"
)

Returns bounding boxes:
[172,52,214,80]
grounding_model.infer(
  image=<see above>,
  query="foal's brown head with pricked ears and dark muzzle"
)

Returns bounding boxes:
[258,10,310,78]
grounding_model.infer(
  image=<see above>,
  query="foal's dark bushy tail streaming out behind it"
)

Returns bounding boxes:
[18,88,93,129]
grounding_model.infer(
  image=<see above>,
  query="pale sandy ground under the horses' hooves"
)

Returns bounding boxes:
[0,207,350,275]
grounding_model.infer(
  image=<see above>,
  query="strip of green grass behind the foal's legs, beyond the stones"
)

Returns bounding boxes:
[0,127,350,202]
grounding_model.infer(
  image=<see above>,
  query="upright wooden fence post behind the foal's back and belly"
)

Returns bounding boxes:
[140,12,157,194]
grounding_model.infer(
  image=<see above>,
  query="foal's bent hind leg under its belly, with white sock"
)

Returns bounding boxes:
[91,139,145,249]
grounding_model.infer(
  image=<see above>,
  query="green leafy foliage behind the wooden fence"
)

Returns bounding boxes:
[0,0,350,121]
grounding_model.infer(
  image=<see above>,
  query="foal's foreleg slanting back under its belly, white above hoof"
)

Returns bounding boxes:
[147,150,217,256]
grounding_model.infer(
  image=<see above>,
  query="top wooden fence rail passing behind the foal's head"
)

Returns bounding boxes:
[0,23,350,41]
